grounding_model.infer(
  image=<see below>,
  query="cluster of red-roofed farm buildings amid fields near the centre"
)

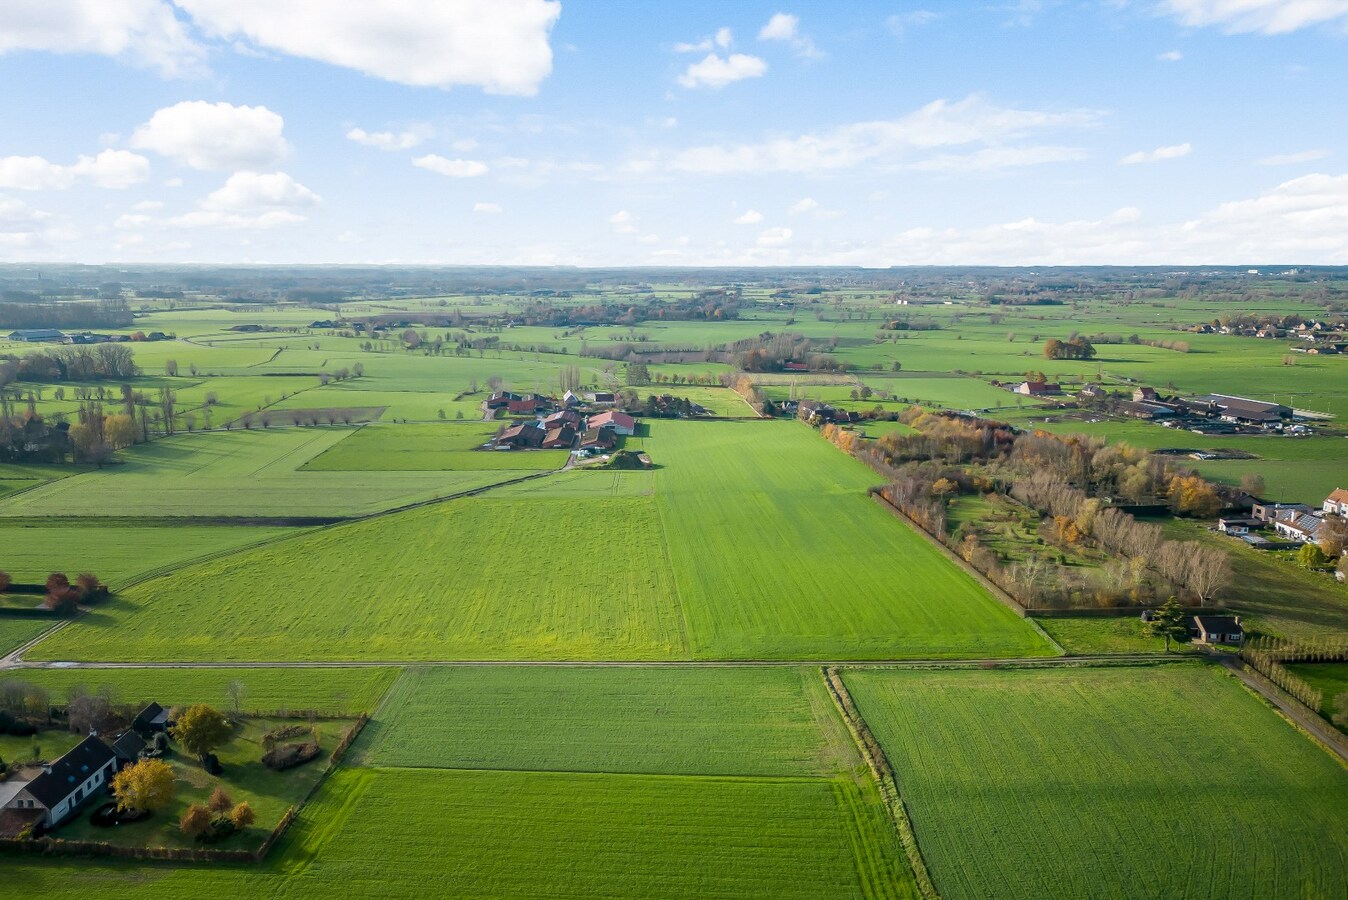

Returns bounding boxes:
[483,391,636,455]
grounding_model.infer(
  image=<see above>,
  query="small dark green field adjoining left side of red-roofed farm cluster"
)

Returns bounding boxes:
[302,422,569,472]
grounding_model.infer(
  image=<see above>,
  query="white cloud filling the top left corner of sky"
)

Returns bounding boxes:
[0,0,205,77]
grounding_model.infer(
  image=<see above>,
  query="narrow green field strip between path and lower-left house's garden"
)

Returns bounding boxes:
[0,665,399,715]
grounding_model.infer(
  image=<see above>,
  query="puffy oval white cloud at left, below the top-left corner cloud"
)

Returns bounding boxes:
[131,100,290,171]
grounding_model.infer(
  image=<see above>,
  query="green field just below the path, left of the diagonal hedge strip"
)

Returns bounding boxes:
[361,667,860,775]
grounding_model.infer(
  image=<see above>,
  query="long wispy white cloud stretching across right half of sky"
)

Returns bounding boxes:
[670,94,1100,174]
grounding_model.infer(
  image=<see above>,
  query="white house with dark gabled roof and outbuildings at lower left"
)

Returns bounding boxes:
[0,703,170,834]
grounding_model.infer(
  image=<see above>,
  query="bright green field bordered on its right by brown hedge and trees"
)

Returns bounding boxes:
[650,422,1051,659]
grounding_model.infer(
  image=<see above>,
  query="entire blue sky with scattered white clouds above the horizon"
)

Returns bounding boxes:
[0,0,1348,265]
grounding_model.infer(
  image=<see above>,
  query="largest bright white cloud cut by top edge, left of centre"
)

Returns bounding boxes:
[177,0,562,94]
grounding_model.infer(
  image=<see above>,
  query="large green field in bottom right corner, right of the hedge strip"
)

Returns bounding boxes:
[845,666,1348,899]
